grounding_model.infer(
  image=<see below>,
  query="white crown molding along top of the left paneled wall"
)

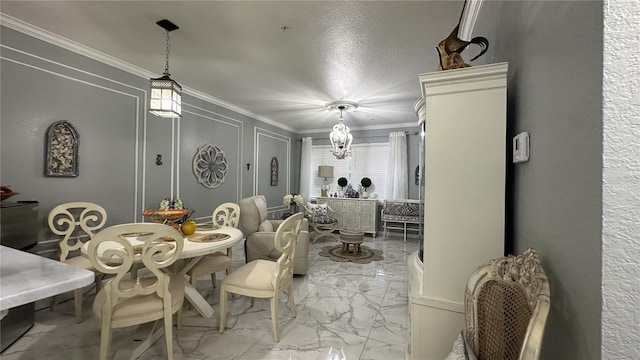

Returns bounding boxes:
[0,12,297,133]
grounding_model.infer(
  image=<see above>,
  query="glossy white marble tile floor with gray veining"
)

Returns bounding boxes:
[0,233,419,360]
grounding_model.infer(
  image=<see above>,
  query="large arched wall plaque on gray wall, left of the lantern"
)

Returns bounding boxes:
[45,120,80,177]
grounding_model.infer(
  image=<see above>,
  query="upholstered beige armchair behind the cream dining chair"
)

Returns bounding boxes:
[240,195,309,275]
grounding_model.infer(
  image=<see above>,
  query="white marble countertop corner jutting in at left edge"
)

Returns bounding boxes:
[0,246,95,310]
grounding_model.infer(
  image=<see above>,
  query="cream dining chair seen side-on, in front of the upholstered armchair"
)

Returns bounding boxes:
[219,213,303,342]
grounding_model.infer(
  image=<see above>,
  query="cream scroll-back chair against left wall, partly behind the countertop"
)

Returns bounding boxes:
[48,201,107,322]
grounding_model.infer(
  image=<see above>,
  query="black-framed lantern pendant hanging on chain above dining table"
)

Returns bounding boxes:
[149,19,182,118]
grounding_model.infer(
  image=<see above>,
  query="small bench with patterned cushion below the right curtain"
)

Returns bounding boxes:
[380,199,422,241]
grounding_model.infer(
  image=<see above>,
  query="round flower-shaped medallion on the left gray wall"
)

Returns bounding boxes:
[193,144,229,189]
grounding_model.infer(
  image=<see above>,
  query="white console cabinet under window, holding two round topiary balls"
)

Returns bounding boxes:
[317,197,378,237]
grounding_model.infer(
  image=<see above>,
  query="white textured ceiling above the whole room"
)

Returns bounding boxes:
[0,0,470,133]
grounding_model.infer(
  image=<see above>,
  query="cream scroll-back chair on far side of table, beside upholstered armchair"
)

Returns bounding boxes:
[189,203,240,287]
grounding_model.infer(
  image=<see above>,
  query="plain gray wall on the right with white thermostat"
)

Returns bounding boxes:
[476,1,603,360]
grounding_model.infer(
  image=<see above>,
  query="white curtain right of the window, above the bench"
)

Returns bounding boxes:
[387,131,409,199]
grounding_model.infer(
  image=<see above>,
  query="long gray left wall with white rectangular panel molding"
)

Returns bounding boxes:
[0,27,300,256]
